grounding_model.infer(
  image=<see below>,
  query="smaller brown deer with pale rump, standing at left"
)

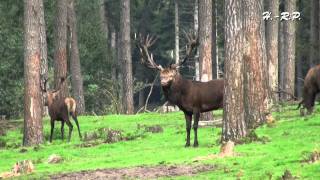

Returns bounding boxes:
[41,78,82,142]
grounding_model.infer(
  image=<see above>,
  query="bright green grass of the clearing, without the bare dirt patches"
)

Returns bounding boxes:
[0,107,320,179]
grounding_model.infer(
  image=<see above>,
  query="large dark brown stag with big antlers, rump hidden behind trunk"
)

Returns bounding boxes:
[137,35,224,147]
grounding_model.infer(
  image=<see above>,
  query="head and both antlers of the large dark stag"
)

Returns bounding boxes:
[137,33,198,86]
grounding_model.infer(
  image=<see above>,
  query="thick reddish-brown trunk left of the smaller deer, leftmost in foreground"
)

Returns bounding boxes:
[23,0,44,146]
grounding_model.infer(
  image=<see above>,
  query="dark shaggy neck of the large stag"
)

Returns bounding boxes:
[162,74,190,105]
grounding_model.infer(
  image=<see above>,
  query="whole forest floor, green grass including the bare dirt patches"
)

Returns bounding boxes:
[0,106,320,179]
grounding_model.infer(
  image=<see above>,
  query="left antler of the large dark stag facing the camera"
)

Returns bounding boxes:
[137,34,163,70]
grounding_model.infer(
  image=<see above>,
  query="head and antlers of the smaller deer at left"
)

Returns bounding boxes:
[40,77,66,106]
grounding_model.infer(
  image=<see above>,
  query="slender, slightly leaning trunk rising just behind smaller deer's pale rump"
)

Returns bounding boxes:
[68,0,85,114]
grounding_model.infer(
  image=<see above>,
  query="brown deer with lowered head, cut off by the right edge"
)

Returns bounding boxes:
[298,65,320,115]
